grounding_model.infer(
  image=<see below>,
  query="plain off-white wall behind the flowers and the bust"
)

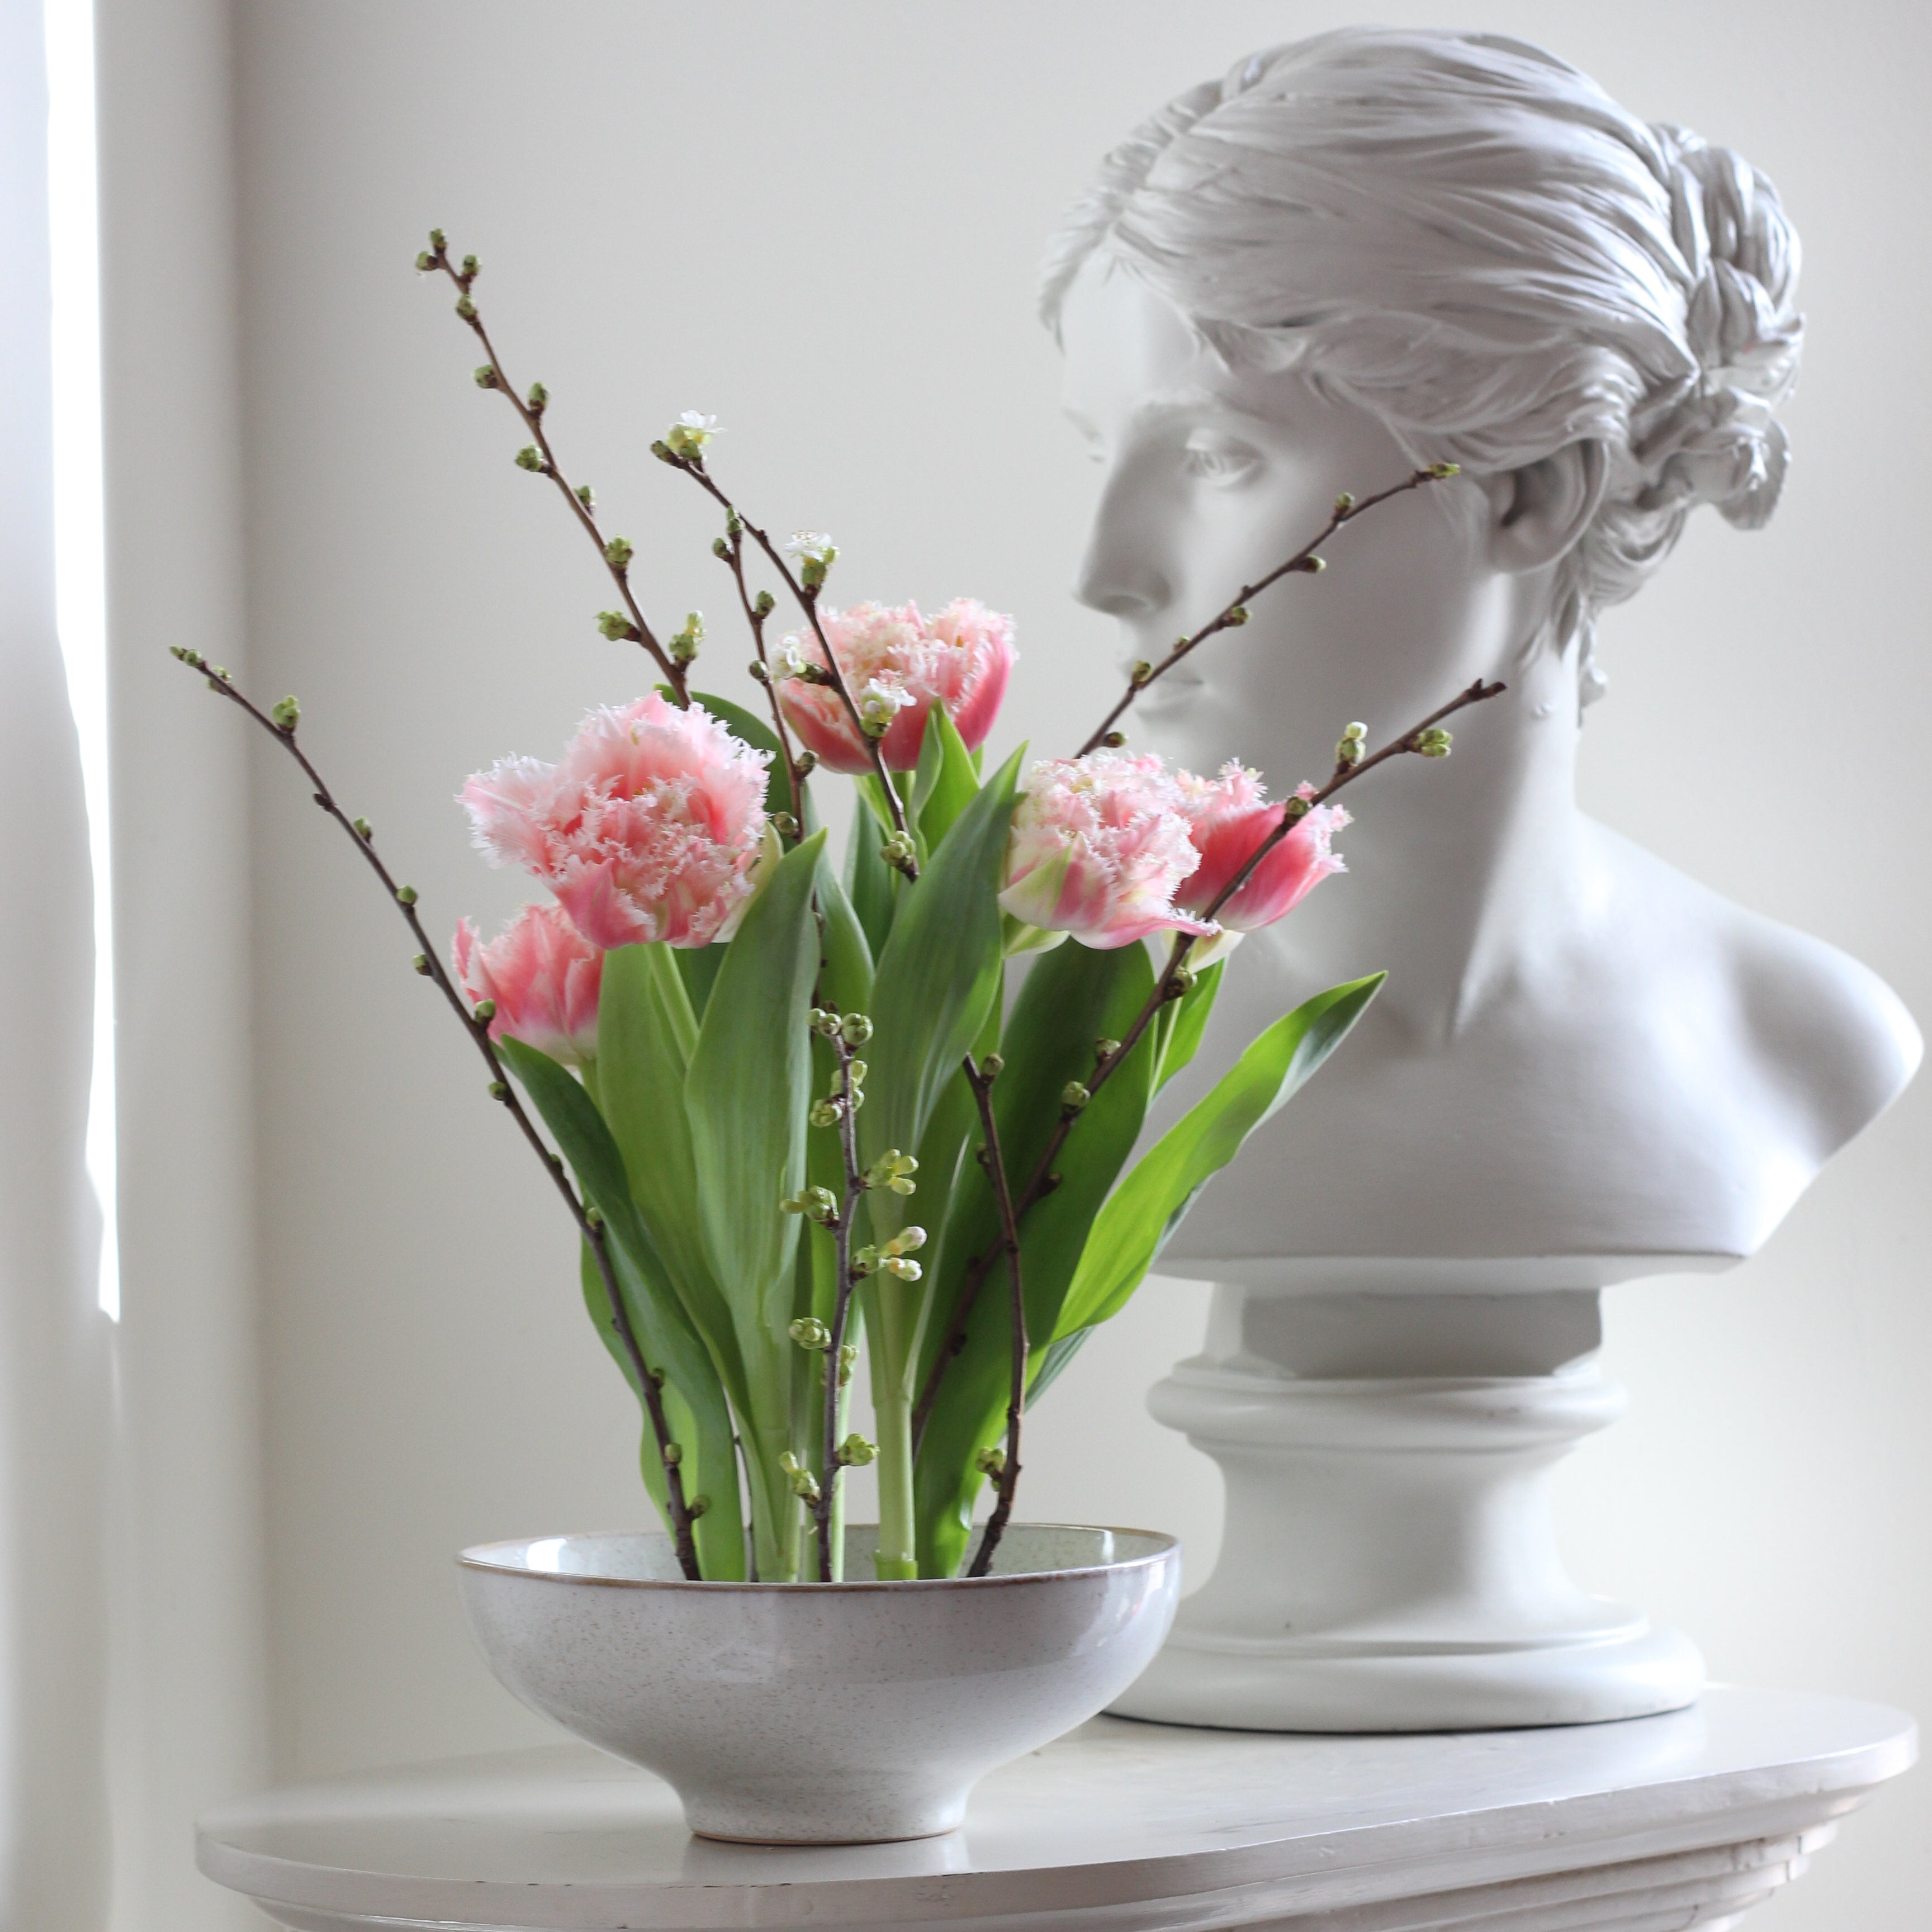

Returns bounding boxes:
[188,0,1932,1932]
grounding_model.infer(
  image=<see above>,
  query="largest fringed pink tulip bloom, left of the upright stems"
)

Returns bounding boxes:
[462,694,769,950]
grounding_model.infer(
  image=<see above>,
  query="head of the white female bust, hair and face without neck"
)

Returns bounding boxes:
[1043,29,1801,779]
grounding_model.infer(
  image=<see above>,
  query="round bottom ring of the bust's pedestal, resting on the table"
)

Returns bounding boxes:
[1111,1623,1704,1731]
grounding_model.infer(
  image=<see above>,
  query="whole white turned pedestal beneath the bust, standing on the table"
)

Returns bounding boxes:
[1115,1287,1704,1731]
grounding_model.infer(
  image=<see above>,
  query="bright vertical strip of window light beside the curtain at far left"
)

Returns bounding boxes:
[44,0,120,1322]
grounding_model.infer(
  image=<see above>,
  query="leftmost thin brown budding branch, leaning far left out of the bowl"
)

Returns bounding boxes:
[174,649,699,1582]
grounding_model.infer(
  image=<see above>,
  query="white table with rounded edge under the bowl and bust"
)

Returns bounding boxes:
[199,1689,1916,1932]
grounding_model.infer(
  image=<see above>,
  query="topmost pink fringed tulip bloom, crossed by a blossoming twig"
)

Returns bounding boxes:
[779,597,1014,771]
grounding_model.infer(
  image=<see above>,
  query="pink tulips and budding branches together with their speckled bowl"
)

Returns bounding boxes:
[178,232,1501,1839]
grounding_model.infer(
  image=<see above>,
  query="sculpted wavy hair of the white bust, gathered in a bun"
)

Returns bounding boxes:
[1041,27,1802,703]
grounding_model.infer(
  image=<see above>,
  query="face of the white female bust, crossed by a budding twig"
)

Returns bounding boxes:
[1060,257,1522,794]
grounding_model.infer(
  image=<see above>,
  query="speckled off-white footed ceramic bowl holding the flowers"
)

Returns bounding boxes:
[458,1522,1181,1845]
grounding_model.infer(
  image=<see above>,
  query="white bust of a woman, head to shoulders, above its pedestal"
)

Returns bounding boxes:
[1045,29,1920,1723]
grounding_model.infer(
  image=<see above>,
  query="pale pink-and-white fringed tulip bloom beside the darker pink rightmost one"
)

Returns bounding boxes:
[999,751,1219,953]
